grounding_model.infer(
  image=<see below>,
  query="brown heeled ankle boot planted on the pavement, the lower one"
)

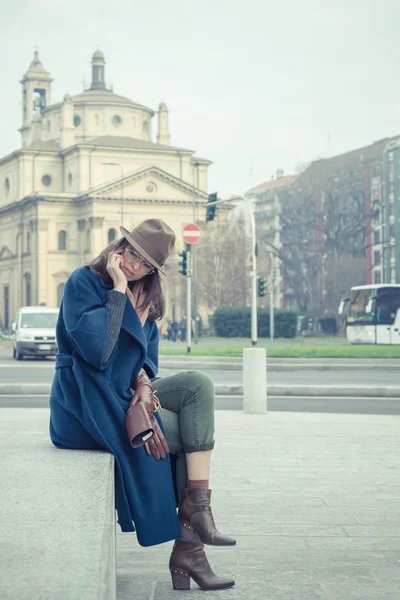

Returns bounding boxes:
[169,521,235,590]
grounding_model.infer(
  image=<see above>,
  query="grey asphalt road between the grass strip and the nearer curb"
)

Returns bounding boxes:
[0,352,400,386]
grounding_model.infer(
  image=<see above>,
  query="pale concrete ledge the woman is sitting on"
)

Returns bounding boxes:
[0,408,116,600]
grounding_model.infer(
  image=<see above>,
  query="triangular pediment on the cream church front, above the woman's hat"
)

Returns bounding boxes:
[82,167,207,202]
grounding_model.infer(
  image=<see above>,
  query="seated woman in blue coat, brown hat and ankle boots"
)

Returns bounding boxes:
[50,219,236,590]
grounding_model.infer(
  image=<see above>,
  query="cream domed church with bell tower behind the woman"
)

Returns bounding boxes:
[0,50,211,329]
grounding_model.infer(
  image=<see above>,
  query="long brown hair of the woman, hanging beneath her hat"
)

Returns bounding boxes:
[87,238,165,321]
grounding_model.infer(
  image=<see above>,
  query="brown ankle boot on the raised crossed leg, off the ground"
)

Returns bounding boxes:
[178,488,236,546]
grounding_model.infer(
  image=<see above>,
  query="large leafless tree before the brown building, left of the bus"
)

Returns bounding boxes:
[259,171,370,313]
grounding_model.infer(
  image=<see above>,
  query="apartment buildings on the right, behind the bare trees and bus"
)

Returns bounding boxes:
[247,138,400,316]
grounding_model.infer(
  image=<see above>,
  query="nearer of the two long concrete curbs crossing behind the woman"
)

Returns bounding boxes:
[0,383,400,398]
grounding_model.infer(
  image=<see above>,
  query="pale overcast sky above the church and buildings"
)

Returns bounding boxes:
[0,0,400,196]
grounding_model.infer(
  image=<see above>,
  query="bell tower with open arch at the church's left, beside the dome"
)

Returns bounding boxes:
[20,49,53,147]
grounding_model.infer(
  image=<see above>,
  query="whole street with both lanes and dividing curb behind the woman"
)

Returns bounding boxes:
[0,349,400,415]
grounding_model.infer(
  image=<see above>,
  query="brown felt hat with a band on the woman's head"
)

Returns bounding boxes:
[119,219,175,275]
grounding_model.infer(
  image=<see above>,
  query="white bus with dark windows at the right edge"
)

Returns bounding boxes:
[338,284,400,344]
